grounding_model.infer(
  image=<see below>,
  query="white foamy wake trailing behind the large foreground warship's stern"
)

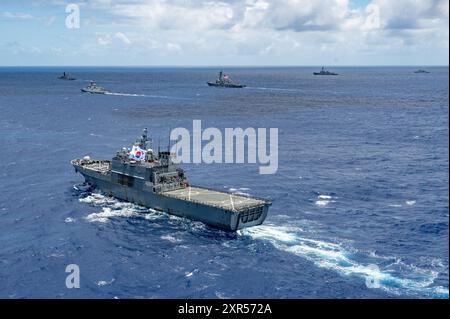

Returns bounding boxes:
[239,225,448,298]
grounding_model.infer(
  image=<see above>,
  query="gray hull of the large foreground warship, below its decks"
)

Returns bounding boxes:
[73,164,270,231]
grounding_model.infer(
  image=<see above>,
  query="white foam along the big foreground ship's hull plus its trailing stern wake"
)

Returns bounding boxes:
[75,189,449,298]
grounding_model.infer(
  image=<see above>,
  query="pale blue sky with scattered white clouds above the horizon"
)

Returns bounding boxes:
[0,0,449,66]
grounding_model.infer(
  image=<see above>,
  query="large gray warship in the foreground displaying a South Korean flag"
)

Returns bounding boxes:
[71,129,271,231]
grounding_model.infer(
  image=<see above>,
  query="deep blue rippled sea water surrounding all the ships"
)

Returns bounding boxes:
[0,67,449,298]
